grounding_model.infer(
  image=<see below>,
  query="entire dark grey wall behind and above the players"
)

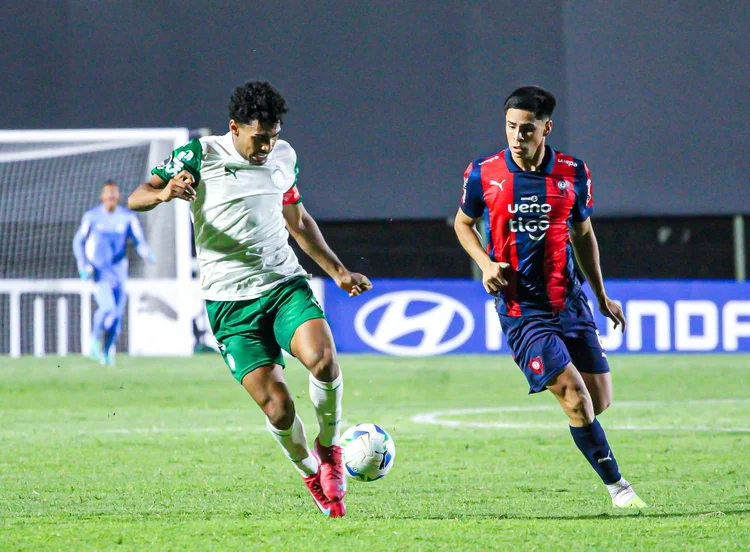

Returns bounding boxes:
[0,0,750,220]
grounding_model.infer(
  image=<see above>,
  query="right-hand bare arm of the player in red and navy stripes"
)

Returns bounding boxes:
[570,218,626,332]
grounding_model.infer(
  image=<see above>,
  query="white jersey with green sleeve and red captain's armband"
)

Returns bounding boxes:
[151,133,305,301]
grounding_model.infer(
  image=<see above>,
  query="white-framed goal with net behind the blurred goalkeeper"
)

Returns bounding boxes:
[0,129,193,356]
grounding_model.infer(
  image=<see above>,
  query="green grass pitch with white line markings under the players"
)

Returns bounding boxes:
[0,355,750,551]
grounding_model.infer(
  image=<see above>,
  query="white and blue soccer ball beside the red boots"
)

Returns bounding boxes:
[341,424,396,481]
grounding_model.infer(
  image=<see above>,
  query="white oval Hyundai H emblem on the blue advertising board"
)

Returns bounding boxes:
[354,291,474,356]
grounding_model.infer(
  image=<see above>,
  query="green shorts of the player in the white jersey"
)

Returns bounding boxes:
[206,276,325,383]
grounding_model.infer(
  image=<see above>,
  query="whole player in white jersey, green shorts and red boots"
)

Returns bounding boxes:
[128,81,372,517]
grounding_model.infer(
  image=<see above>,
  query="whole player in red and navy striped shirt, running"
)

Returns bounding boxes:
[455,86,645,508]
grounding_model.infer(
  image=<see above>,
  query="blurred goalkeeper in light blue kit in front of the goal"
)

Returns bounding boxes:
[73,181,154,364]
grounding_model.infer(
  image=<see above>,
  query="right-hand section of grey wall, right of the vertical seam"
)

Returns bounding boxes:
[565,0,750,216]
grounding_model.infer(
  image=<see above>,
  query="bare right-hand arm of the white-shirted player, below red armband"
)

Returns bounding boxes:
[284,203,372,297]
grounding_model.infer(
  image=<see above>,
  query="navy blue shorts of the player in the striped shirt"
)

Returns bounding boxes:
[499,293,609,393]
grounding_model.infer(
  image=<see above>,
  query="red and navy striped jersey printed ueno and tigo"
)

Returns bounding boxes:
[461,146,594,316]
